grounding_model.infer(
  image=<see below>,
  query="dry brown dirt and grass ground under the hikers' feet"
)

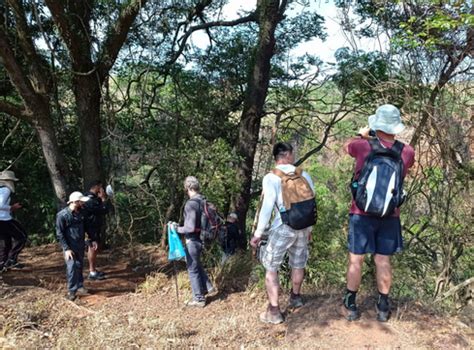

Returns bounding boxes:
[0,244,473,349]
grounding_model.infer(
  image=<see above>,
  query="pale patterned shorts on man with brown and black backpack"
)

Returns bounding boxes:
[260,225,311,272]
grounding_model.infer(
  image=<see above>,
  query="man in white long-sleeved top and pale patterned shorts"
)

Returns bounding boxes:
[250,142,314,324]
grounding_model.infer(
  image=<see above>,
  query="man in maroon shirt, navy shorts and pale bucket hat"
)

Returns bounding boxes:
[342,104,415,322]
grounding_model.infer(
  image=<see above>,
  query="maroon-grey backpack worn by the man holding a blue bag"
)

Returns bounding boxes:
[193,198,225,244]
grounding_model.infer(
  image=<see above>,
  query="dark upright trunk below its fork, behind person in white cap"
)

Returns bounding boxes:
[73,73,104,187]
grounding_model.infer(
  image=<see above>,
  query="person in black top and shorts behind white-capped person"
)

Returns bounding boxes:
[84,181,109,280]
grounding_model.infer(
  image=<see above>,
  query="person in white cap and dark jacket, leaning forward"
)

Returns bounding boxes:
[56,191,97,301]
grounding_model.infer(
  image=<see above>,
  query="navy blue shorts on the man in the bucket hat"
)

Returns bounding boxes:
[347,214,403,255]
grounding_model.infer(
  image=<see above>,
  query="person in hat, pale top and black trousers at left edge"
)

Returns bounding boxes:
[0,170,28,271]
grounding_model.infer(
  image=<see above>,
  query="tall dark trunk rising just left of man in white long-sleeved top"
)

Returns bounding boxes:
[234,0,282,244]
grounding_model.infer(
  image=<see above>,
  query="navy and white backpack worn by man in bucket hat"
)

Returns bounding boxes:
[351,139,405,217]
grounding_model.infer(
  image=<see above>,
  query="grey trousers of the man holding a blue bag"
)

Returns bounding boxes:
[185,239,212,301]
